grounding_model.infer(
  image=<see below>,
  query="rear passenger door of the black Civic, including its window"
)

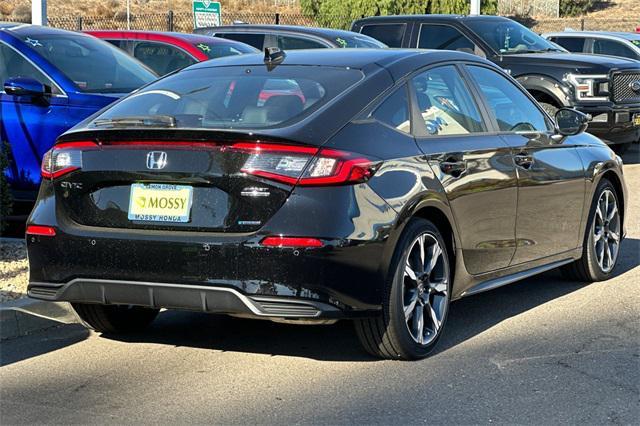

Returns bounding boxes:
[411,65,517,275]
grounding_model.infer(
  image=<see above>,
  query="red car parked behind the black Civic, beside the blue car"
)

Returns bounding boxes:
[87,31,257,75]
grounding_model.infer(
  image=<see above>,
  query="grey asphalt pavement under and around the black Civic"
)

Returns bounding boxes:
[0,145,640,424]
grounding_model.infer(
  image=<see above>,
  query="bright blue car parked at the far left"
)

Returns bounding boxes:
[0,23,157,214]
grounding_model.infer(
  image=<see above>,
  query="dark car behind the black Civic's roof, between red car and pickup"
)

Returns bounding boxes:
[193,24,387,50]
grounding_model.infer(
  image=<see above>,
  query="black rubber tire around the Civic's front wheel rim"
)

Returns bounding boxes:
[561,179,622,283]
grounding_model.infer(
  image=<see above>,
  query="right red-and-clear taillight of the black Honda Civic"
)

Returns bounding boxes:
[231,142,375,186]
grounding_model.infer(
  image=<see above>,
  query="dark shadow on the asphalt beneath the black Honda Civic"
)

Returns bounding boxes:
[102,239,640,361]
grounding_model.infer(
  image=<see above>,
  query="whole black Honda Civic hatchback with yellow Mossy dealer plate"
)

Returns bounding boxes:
[27,49,626,359]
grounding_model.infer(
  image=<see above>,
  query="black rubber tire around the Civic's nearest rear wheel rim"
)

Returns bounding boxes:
[355,218,452,360]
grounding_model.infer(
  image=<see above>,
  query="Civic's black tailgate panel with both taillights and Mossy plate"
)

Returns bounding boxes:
[43,132,375,233]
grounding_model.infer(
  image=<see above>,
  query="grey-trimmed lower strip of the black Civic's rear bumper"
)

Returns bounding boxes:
[28,278,345,319]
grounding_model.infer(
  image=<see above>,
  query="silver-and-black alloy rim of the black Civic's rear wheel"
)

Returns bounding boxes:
[402,232,449,345]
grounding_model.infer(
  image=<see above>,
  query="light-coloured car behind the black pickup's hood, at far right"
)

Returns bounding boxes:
[542,31,640,61]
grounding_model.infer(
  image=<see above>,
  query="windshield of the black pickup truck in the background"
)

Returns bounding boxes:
[467,19,563,55]
